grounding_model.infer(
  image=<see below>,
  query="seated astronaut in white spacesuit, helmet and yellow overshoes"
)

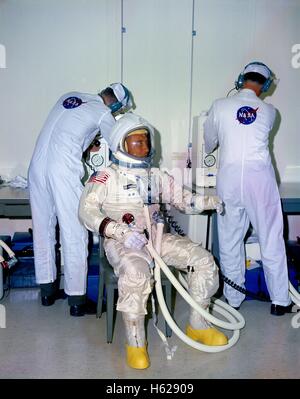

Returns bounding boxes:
[79,113,228,369]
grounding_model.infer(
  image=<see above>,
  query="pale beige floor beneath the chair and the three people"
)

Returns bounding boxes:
[0,289,300,379]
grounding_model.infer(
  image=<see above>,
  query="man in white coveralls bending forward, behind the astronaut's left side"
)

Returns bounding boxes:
[28,83,131,316]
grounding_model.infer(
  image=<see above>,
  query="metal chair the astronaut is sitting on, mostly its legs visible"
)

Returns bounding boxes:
[97,239,172,343]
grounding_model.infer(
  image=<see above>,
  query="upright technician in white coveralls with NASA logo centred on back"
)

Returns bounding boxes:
[204,62,293,315]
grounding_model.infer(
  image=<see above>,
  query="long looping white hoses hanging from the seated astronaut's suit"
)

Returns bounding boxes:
[144,206,245,352]
